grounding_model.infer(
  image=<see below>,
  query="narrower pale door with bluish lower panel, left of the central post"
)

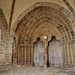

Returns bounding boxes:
[34,38,45,66]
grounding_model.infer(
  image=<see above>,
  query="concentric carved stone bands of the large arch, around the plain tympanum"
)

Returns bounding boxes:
[11,2,74,40]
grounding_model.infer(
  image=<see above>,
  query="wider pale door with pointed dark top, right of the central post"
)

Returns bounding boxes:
[48,36,62,67]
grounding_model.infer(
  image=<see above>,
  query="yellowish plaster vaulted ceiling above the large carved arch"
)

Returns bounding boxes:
[0,0,74,29]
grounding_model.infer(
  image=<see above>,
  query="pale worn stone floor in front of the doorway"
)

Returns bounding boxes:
[0,67,75,75]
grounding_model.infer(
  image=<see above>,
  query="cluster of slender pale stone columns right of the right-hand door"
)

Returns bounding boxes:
[63,40,75,68]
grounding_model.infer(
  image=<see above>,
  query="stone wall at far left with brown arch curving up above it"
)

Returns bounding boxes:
[0,9,12,72]
